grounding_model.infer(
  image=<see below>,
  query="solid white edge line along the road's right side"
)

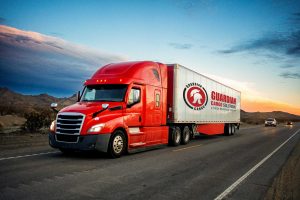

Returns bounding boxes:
[215,129,300,200]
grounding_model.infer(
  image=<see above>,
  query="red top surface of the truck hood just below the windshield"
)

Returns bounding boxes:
[59,102,123,116]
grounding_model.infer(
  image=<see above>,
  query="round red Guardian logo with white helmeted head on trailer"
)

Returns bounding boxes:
[183,83,207,110]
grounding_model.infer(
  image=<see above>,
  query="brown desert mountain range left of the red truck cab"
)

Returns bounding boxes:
[0,87,76,115]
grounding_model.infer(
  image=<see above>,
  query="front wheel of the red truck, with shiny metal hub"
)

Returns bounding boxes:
[107,130,127,158]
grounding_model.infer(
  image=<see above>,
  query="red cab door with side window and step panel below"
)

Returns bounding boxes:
[124,85,145,148]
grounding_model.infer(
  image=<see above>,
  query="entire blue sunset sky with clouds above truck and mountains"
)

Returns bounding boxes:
[0,0,300,112]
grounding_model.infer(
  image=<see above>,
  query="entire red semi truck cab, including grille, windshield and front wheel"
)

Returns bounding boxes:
[49,61,168,157]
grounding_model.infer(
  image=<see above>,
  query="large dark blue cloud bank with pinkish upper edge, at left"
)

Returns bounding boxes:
[0,25,126,96]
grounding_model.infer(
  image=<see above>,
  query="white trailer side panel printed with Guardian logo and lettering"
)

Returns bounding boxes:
[168,64,241,124]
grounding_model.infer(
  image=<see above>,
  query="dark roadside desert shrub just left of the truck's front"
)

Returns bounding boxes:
[23,110,52,132]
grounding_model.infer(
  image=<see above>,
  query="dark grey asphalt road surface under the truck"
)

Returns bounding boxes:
[0,124,300,200]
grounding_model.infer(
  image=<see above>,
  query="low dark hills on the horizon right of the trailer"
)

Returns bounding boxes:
[241,110,300,124]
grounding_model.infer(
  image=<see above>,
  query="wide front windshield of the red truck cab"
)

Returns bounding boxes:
[80,85,127,102]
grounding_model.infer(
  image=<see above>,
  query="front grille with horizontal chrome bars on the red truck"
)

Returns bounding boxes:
[56,112,84,135]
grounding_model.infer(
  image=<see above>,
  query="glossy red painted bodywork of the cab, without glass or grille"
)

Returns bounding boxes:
[61,61,168,149]
